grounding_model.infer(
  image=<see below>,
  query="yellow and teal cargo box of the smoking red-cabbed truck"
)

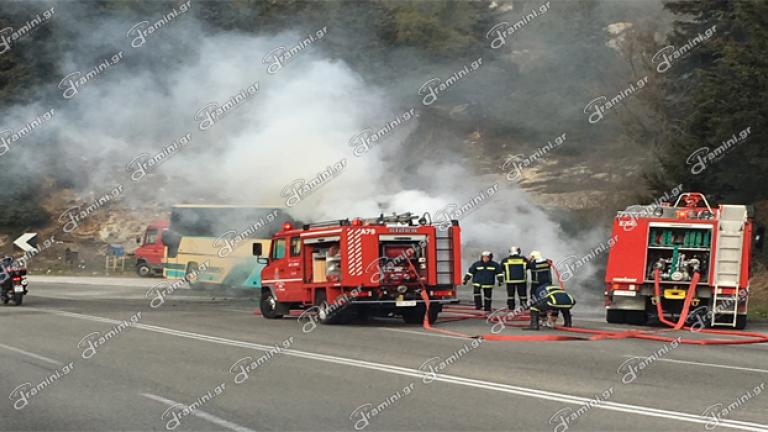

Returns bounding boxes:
[163,204,290,289]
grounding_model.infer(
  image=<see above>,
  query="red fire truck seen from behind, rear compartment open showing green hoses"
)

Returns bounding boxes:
[605,192,753,329]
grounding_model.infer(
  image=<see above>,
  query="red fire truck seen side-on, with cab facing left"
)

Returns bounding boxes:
[253,213,462,323]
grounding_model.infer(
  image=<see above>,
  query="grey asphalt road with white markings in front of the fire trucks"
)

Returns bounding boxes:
[0,280,768,432]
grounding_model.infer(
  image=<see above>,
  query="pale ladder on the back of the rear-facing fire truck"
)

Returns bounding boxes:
[711,205,747,327]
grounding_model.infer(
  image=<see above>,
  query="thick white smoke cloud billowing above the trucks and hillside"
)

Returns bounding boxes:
[6,10,600,300]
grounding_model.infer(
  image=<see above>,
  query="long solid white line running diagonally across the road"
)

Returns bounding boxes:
[33,308,768,432]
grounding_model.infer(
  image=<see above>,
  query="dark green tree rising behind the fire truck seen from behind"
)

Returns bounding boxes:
[648,0,768,203]
